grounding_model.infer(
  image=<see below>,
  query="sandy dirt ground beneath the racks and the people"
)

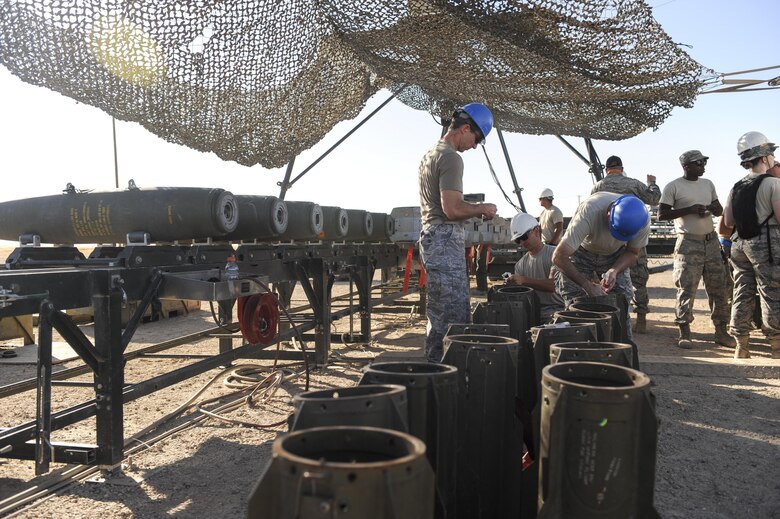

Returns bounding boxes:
[0,254,780,519]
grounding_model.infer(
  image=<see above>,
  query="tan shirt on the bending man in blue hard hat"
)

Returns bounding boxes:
[561,191,650,256]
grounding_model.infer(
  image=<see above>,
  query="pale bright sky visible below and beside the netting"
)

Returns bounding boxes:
[0,0,780,245]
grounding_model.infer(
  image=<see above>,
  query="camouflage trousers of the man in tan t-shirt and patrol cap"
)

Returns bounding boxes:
[672,233,732,325]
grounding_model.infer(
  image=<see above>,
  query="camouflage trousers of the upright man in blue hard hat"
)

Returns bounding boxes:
[420,224,470,362]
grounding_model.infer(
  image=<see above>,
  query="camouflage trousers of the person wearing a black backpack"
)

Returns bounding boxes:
[729,227,780,339]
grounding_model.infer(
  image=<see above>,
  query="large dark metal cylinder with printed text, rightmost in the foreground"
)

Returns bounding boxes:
[538,362,659,519]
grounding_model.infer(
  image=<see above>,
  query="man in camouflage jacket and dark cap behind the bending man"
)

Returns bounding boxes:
[590,155,661,333]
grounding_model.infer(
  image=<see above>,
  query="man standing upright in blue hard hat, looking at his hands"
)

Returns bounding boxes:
[419,103,496,362]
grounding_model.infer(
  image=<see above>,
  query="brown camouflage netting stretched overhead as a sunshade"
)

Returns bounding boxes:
[0,0,706,168]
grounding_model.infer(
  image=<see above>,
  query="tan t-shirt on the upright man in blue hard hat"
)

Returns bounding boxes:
[418,140,463,227]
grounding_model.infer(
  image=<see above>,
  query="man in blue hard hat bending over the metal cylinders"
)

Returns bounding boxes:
[553,191,650,336]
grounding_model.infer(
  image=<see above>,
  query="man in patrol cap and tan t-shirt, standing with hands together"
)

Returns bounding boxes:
[658,150,736,349]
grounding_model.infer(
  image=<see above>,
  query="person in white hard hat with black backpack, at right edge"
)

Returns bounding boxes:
[719,132,780,359]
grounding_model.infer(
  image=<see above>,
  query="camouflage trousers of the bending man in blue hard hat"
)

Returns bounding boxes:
[555,247,634,339]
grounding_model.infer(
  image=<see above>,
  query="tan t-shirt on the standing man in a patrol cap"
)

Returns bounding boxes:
[659,177,718,234]
